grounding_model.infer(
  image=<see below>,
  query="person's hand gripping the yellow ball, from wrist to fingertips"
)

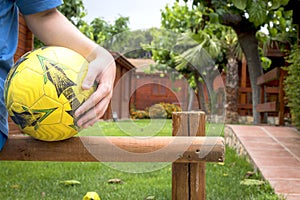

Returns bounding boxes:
[75,46,116,128]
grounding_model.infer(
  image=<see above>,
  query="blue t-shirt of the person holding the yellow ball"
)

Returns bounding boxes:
[0,0,62,150]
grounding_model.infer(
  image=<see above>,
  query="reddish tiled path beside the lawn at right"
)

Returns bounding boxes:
[225,125,300,200]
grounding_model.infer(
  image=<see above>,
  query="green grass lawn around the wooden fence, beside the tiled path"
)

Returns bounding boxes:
[0,120,279,200]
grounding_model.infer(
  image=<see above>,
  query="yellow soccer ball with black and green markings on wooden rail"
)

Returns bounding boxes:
[4,46,95,141]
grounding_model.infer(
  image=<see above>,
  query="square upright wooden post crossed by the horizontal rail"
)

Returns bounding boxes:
[172,112,205,200]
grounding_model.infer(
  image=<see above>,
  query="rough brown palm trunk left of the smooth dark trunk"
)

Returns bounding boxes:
[225,58,239,124]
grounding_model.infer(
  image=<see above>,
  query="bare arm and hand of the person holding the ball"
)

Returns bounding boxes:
[24,9,116,128]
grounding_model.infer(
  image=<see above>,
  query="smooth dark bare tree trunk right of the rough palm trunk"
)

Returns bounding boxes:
[237,31,263,124]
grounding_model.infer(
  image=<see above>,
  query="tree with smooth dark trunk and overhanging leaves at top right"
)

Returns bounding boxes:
[184,0,288,124]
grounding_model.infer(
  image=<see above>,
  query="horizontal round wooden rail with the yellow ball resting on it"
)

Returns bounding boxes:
[0,135,224,163]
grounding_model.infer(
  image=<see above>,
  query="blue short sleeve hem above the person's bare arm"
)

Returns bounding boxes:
[16,0,62,15]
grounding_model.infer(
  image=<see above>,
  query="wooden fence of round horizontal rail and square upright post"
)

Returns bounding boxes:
[0,112,225,200]
